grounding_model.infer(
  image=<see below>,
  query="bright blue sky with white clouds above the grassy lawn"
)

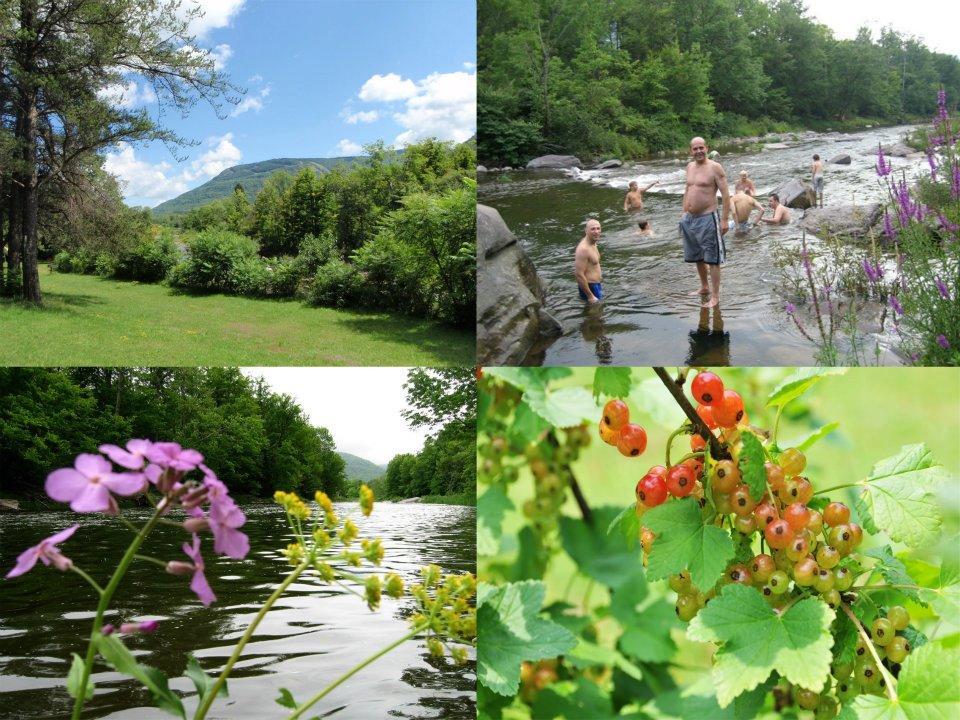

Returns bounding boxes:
[106,0,476,206]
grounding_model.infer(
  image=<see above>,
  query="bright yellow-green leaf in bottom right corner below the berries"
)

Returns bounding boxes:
[853,643,960,720]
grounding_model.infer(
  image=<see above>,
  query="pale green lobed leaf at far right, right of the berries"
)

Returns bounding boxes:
[856,443,951,547]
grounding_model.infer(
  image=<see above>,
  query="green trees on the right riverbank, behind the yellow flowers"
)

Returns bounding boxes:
[358,368,477,498]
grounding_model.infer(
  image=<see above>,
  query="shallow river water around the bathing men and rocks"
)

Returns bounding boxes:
[479,126,927,366]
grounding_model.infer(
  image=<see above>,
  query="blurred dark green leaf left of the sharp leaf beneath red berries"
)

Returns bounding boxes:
[560,506,643,588]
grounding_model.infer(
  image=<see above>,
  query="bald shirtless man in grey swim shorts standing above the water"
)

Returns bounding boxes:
[680,137,730,308]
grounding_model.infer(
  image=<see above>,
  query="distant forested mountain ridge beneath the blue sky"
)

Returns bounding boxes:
[153,157,365,215]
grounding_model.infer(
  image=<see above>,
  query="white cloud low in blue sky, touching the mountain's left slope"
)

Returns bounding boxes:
[103,133,243,206]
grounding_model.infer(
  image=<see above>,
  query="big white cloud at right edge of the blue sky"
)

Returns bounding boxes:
[393,72,477,147]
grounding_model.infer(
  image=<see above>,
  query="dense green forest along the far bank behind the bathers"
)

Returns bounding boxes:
[477,0,960,165]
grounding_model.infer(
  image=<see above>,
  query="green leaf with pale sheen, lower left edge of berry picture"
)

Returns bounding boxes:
[477,580,576,695]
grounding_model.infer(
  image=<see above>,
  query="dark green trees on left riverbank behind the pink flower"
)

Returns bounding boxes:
[0,367,345,497]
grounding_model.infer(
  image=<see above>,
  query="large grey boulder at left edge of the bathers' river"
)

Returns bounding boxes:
[477,203,561,365]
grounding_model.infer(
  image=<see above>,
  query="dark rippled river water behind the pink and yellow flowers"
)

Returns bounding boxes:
[0,503,476,720]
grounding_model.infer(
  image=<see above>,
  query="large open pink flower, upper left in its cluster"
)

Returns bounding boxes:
[44,453,146,515]
